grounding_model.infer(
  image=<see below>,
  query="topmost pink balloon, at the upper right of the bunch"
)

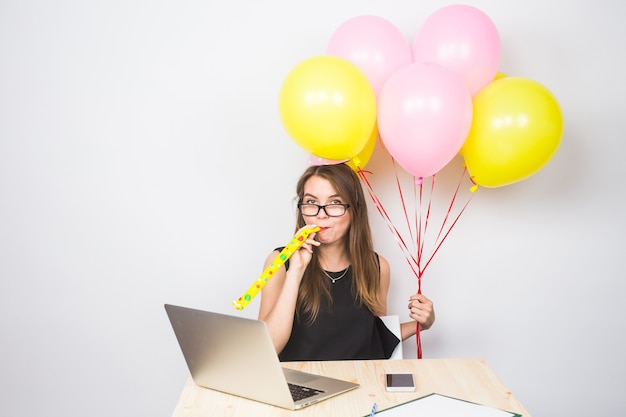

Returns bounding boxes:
[413,5,501,95]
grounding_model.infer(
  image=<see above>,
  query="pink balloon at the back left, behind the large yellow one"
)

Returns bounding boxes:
[326,15,412,96]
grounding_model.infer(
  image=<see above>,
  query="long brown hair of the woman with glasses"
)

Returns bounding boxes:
[295,164,380,323]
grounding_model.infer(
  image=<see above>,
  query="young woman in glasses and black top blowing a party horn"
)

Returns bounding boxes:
[259,164,435,361]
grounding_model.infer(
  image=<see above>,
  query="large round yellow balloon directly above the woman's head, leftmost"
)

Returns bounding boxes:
[279,55,376,160]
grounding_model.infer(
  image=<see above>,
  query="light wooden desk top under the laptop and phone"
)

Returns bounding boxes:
[173,358,530,417]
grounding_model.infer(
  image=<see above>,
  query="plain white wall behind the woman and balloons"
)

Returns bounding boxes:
[0,0,626,417]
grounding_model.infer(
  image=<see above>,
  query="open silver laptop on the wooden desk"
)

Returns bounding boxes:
[165,304,359,410]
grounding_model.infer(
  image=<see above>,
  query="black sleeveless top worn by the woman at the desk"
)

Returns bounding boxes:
[278,249,400,361]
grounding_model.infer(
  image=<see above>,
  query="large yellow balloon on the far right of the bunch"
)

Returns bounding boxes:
[462,77,563,187]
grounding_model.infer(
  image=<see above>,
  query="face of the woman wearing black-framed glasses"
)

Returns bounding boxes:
[302,175,351,243]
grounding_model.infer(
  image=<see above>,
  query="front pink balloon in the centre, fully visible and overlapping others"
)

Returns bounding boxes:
[377,62,473,178]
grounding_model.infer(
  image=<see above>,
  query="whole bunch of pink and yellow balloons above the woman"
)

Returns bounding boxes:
[279,5,563,187]
